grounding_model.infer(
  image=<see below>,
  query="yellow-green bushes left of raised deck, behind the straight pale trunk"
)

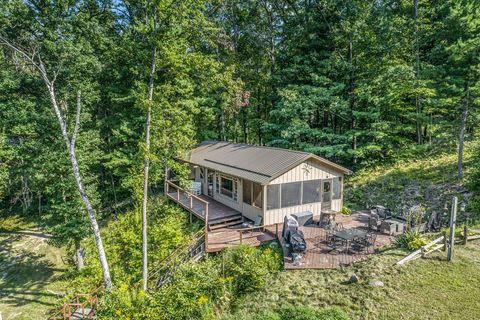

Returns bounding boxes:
[76,197,200,285]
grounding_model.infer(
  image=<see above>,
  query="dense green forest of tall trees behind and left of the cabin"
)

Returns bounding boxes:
[0,0,480,319]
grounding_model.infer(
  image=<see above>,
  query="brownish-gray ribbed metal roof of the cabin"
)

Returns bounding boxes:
[180,141,350,184]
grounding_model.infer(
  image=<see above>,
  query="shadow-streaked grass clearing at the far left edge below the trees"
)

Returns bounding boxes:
[0,217,67,320]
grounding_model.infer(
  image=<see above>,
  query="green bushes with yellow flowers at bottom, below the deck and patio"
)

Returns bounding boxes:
[99,244,281,319]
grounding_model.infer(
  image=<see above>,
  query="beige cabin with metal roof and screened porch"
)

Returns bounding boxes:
[169,141,350,225]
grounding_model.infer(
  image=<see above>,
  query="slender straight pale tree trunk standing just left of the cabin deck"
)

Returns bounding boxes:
[142,14,157,291]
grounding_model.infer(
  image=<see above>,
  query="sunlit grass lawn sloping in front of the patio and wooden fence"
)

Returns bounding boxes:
[223,241,480,320]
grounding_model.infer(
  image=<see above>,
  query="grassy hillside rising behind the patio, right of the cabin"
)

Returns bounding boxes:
[345,143,473,213]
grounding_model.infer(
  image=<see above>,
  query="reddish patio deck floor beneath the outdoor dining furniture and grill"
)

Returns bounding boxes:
[278,213,393,270]
